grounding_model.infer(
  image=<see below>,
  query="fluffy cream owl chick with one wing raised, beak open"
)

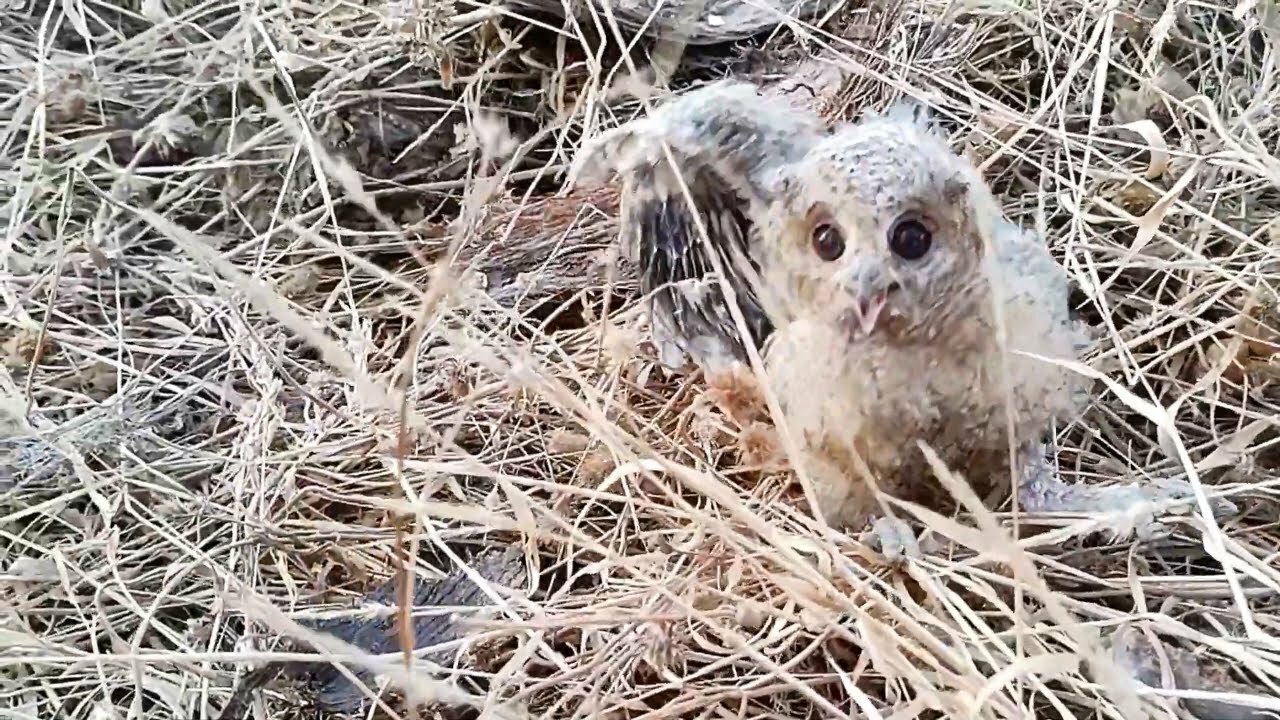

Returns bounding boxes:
[573,81,1239,555]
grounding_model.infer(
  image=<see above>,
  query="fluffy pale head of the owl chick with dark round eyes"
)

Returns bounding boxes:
[760,104,998,345]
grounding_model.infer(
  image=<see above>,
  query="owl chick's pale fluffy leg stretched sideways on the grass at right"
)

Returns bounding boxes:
[1018,443,1238,543]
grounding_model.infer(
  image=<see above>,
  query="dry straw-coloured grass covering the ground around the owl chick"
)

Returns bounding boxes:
[0,0,1280,719]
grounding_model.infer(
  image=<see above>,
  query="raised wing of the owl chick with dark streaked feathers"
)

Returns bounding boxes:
[572,81,827,372]
